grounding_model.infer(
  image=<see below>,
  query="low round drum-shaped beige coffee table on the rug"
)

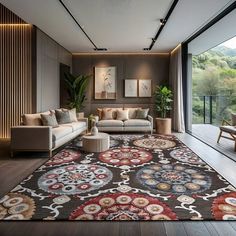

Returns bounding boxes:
[82,133,110,152]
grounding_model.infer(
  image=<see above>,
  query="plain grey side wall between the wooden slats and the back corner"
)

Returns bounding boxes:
[36,29,72,112]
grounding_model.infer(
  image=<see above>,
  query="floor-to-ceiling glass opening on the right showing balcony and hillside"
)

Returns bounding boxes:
[184,6,236,160]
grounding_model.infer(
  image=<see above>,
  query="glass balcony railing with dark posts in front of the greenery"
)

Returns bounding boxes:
[192,95,236,126]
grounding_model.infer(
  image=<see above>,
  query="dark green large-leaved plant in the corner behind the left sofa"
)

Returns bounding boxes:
[64,73,91,112]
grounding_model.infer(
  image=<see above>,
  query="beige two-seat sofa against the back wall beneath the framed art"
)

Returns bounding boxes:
[96,108,153,134]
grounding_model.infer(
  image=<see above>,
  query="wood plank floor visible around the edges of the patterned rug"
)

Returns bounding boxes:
[0,134,236,236]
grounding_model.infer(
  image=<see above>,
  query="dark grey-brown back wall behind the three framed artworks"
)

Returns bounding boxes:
[72,54,169,115]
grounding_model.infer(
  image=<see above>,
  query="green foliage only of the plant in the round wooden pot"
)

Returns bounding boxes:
[154,86,173,118]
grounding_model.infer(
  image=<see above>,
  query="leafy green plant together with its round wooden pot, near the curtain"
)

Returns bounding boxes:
[154,86,173,134]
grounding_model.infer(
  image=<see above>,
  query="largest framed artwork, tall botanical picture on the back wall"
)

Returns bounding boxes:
[94,66,116,99]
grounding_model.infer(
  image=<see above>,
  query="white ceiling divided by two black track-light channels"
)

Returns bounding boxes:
[0,0,233,53]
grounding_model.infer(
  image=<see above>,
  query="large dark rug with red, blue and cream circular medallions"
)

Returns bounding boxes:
[0,135,236,220]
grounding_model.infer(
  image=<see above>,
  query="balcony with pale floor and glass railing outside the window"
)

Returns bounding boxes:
[191,95,236,161]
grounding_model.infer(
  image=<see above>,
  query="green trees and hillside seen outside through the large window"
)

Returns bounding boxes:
[192,46,236,126]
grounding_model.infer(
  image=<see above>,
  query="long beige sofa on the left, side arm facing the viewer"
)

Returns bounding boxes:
[11,111,87,156]
